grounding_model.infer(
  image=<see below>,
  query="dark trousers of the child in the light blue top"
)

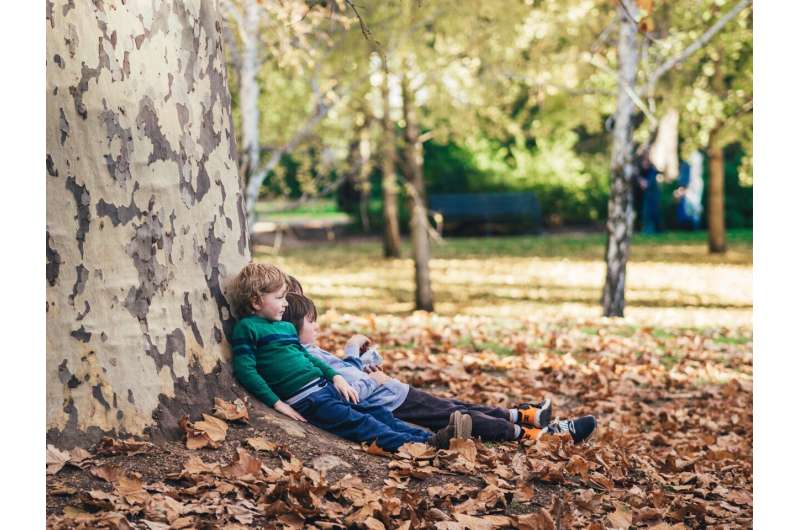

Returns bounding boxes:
[392,387,515,442]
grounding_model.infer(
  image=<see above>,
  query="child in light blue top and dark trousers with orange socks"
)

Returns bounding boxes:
[283,293,596,443]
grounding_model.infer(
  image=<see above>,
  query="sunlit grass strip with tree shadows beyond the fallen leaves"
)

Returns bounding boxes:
[256,230,753,330]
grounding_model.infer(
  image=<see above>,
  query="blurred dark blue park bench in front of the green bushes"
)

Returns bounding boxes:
[428,192,541,233]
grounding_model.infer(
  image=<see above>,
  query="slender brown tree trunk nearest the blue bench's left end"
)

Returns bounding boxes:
[402,70,433,311]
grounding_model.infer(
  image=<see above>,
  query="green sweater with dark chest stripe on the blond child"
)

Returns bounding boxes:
[231,315,337,407]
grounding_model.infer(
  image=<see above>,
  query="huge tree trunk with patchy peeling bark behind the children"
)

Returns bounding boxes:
[46,0,250,445]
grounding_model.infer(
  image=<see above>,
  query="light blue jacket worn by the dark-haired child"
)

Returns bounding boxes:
[303,344,408,411]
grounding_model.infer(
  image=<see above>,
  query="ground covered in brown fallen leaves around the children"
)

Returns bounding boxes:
[47,311,753,530]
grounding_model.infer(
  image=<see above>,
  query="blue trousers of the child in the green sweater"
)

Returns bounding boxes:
[292,384,432,451]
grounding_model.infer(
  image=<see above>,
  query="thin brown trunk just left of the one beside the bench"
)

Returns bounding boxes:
[381,59,400,258]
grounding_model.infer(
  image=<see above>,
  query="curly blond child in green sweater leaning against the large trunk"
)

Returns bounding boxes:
[229,263,472,451]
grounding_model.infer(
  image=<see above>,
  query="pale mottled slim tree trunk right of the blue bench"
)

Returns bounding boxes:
[603,0,639,317]
